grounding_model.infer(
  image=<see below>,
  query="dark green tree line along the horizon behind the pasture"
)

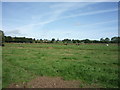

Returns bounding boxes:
[0,30,120,43]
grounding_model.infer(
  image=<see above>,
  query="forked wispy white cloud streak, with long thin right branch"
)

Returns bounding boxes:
[16,3,117,30]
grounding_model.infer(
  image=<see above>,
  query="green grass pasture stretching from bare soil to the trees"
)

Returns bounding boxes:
[2,43,119,88]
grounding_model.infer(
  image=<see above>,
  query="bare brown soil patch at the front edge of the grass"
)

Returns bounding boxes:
[8,76,80,88]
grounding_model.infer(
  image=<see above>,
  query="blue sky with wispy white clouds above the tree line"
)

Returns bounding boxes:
[2,2,118,40]
